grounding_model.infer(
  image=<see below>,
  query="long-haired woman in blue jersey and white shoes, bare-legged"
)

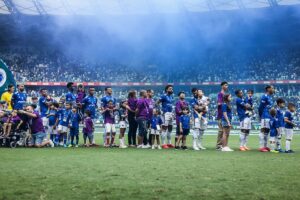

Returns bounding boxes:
[222,94,233,151]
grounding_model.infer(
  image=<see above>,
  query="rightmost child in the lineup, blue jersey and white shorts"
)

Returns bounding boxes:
[284,103,296,153]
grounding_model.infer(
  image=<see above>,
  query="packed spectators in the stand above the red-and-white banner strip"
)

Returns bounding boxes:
[0,49,300,82]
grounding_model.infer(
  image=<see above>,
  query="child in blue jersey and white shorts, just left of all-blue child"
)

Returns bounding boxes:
[57,102,72,147]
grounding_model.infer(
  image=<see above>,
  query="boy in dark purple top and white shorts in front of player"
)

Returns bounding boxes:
[102,100,116,147]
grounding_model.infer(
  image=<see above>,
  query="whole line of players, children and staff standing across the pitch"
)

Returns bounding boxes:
[0,82,296,153]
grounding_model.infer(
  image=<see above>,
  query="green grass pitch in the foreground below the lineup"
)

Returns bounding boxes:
[0,132,300,200]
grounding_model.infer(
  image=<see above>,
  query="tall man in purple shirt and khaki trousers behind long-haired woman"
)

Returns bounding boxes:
[216,81,228,150]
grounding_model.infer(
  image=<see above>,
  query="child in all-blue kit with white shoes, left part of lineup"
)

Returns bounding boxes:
[69,106,81,147]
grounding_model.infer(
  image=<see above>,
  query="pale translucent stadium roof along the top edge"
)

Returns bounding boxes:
[0,0,300,15]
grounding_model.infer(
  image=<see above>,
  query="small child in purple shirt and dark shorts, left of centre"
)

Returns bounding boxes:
[82,110,94,147]
